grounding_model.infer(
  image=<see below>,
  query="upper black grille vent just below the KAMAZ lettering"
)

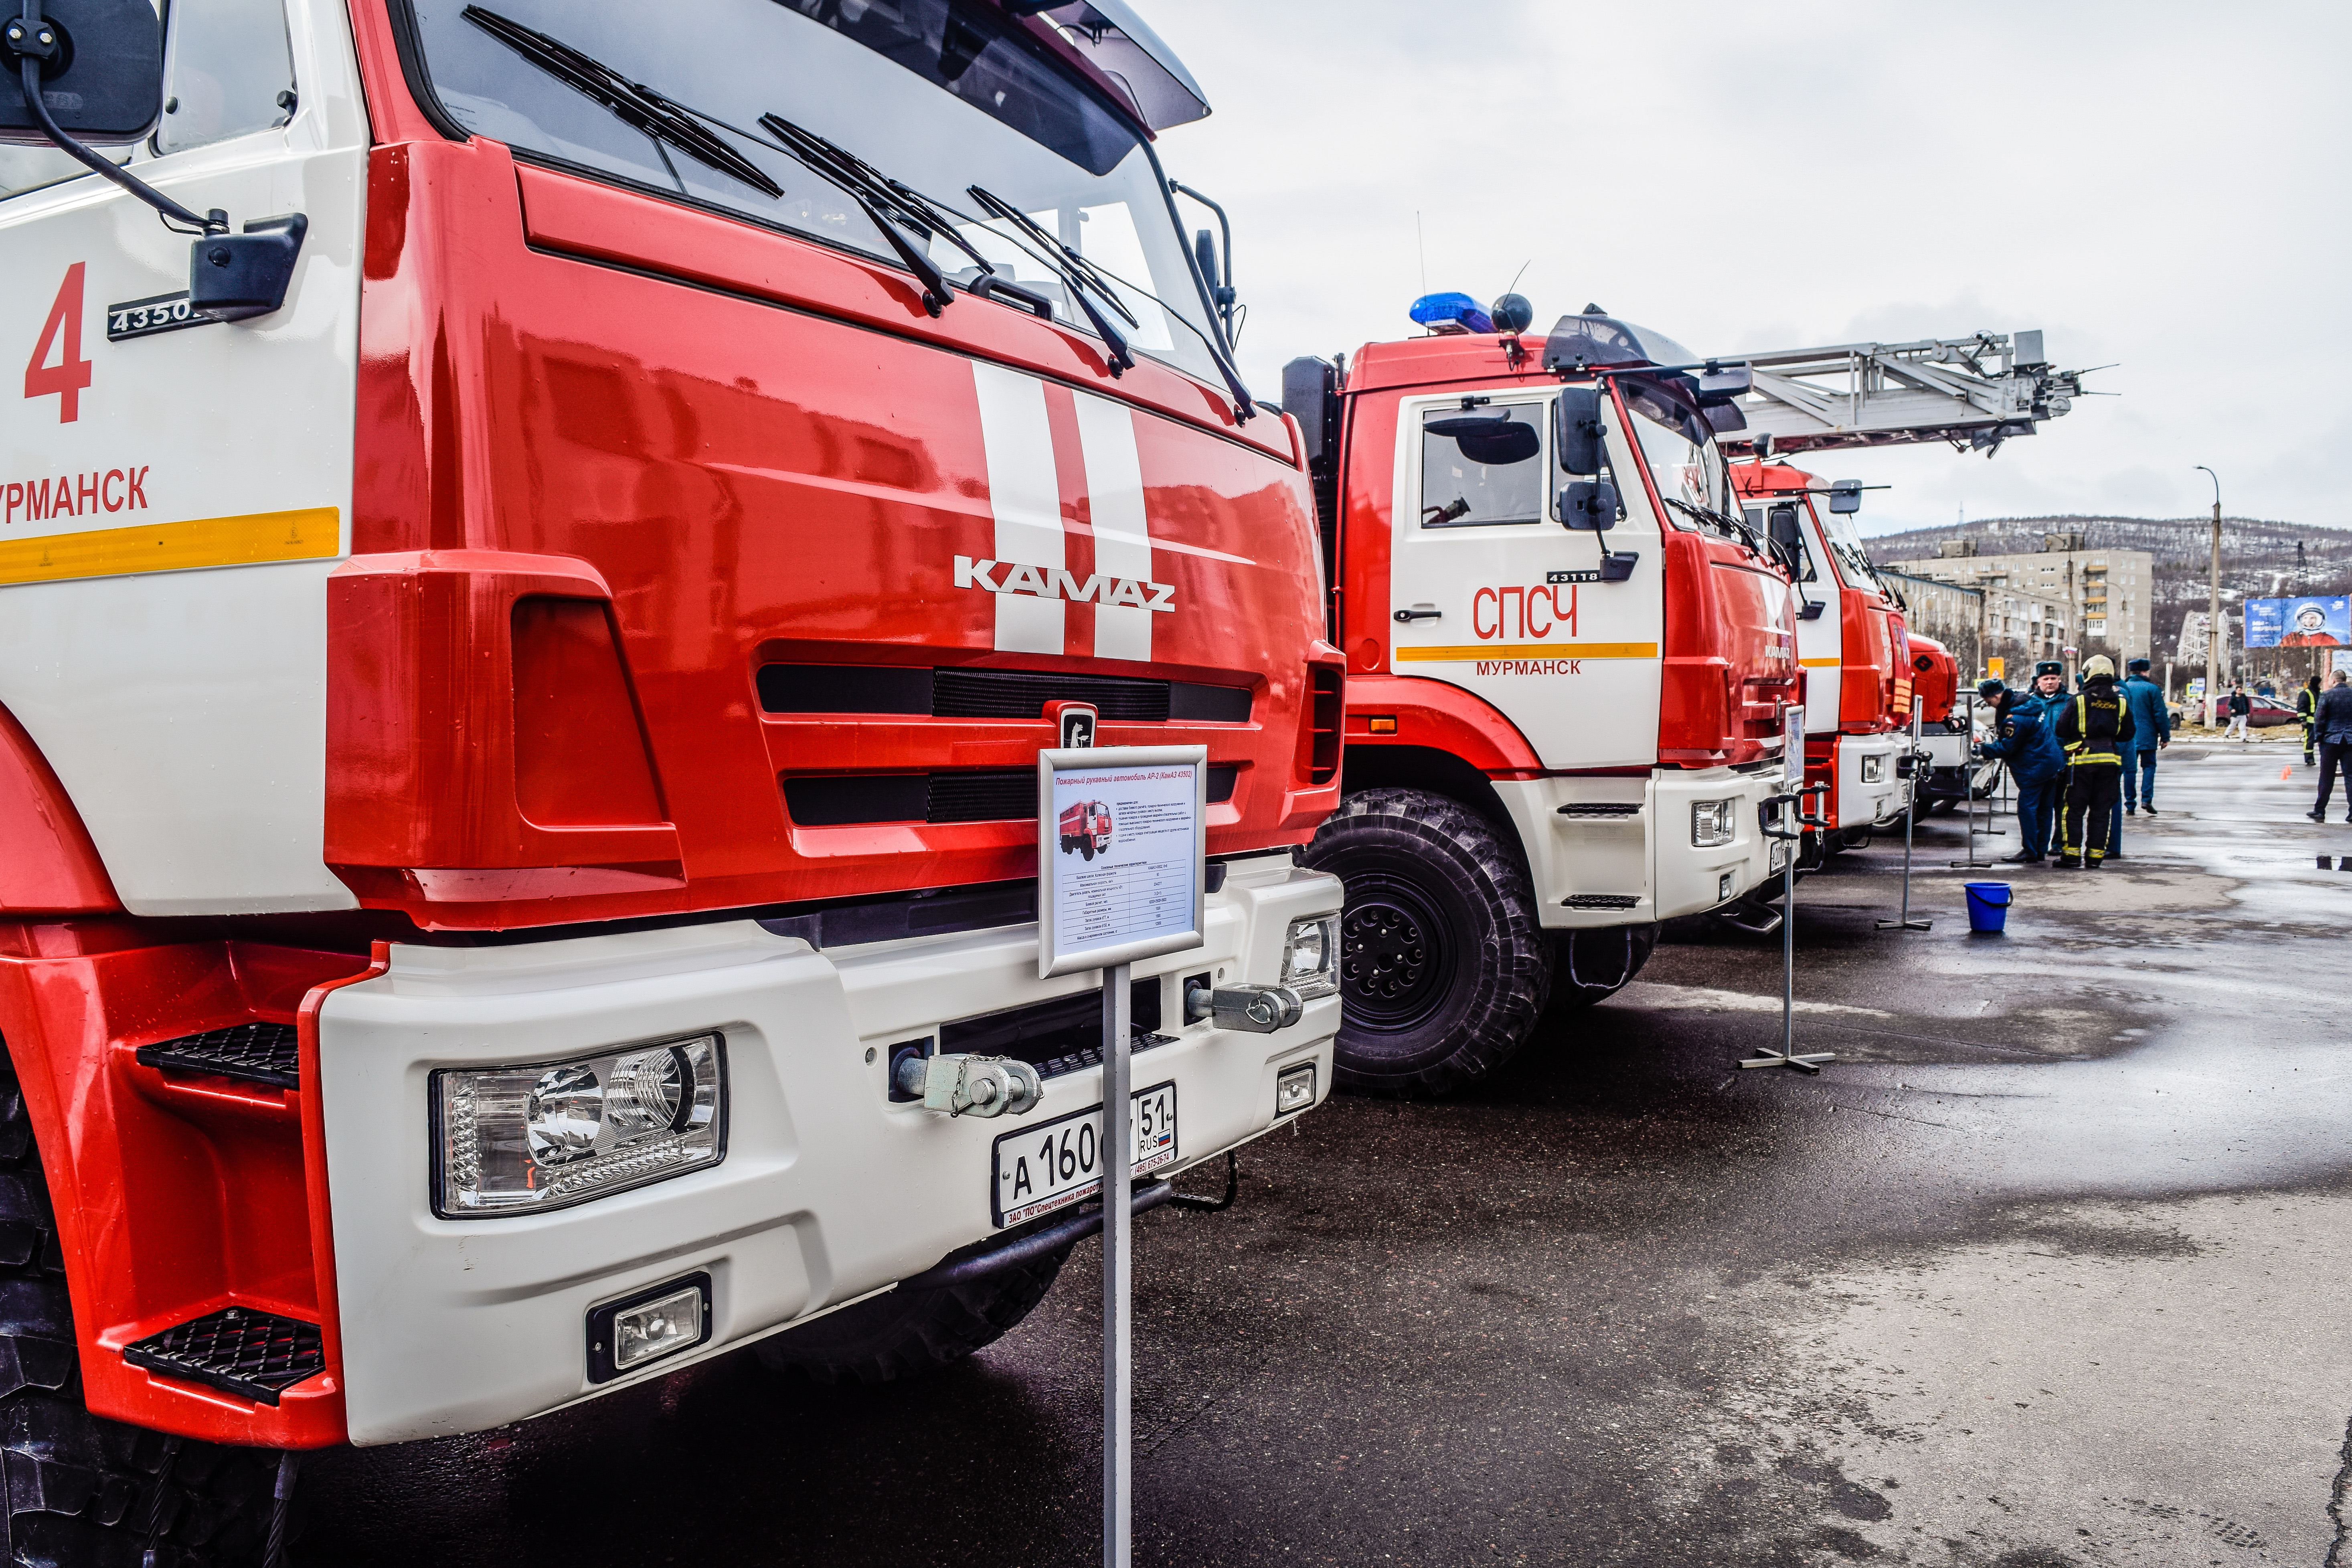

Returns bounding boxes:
[760,665,1251,724]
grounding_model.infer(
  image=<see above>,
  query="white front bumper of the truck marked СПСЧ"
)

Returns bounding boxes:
[1494,769,1781,929]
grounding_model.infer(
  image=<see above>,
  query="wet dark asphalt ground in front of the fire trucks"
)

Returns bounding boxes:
[296,743,2352,1568]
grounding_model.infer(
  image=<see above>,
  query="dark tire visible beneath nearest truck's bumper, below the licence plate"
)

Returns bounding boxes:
[753,1246,1070,1385]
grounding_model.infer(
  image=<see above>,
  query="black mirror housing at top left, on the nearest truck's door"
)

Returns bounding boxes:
[0,0,162,146]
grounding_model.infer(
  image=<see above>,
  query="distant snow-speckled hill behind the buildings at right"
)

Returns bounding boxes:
[1868,517,2352,649]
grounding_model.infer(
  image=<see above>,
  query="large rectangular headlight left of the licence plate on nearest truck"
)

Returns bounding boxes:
[433,1034,727,1220]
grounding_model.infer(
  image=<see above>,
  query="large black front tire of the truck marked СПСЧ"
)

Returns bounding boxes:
[1306,787,1552,1095]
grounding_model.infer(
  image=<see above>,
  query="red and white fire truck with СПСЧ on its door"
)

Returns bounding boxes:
[1284,296,1797,1093]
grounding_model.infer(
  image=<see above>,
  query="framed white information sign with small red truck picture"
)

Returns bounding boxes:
[1037,745,1209,978]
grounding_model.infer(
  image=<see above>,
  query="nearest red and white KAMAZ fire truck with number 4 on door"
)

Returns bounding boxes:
[0,0,1345,1563]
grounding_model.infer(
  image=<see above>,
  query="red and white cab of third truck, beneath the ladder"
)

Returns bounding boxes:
[1731,461,1912,865]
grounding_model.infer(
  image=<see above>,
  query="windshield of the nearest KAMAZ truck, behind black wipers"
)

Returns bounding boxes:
[412,0,1219,381]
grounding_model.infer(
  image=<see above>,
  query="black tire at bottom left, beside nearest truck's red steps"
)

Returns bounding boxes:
[0,1062,277,1568]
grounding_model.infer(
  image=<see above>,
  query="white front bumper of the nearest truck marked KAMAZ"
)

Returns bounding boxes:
[320,856,1341,1443]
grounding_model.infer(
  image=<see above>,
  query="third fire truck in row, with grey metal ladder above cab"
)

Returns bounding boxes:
[1724,332,2084,846]
